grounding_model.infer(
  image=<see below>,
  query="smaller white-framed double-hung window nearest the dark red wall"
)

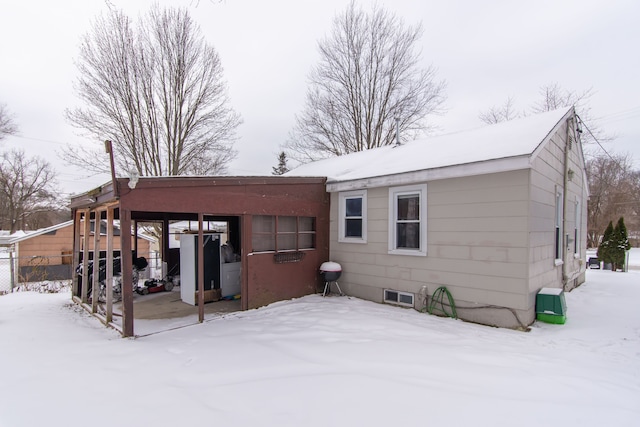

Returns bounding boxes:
[338,190,367,243]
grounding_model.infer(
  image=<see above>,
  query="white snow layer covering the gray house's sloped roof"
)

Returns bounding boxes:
[285,107,573,184]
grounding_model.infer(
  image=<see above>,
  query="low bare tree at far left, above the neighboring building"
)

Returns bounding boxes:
[0,150,59,233]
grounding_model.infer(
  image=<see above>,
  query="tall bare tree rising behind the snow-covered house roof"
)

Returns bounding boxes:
[285,1,445,162]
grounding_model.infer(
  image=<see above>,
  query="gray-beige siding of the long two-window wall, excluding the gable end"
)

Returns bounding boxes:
[330,171,529,318]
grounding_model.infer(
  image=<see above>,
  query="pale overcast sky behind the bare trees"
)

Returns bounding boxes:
[0,0,640,197]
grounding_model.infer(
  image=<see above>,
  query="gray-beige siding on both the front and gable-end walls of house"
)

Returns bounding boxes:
[322,111,588,327]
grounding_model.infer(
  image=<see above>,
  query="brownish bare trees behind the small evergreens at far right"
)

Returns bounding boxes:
[586,154,640,247]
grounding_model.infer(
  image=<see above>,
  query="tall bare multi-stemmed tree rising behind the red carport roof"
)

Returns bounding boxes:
[65,5,241,176]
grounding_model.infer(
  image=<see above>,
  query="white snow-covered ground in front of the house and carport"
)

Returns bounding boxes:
[0,252,640,427]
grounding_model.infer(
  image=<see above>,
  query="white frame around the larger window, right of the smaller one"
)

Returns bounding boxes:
[389,184,427,256]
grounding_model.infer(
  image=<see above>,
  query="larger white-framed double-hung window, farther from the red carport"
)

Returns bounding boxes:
[389,184,427,256]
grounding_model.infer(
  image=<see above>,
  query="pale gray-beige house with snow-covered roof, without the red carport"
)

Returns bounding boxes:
[286,108,588,328]
